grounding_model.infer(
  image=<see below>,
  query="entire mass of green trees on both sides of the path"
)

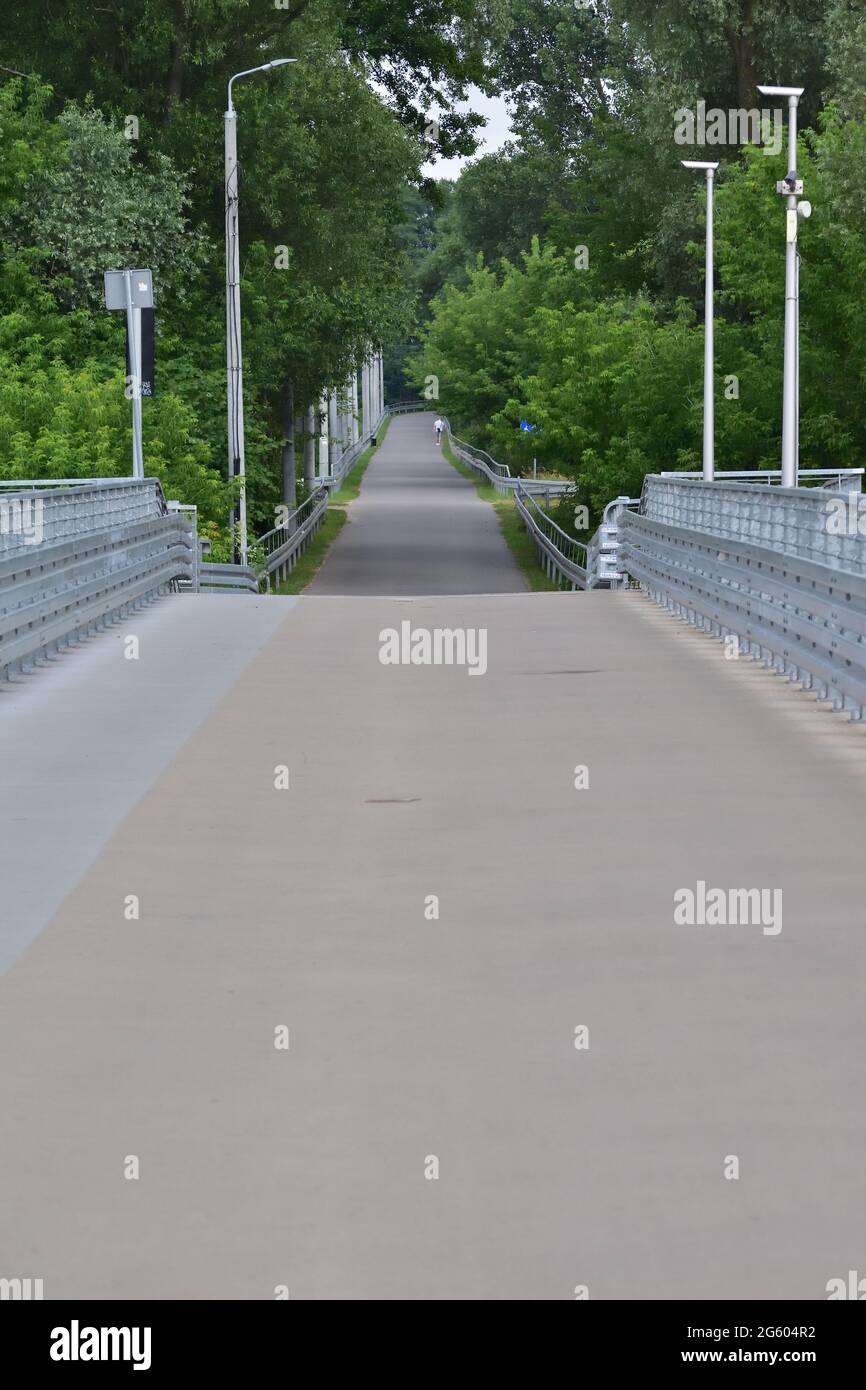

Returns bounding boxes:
[0,0,866,530]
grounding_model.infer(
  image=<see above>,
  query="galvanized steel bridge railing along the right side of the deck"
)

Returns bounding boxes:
[620,477,866,720]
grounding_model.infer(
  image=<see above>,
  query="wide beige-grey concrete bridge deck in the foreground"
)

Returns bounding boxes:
[0,421,866,1300]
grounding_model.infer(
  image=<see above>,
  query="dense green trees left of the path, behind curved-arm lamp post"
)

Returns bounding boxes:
[0,0,505,530]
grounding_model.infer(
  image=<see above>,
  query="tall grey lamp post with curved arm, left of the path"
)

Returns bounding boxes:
[225,58,297,564]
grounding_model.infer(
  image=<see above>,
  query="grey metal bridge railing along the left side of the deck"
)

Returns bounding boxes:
[0,478,197,678]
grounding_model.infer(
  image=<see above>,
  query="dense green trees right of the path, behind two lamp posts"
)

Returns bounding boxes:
[406,0,866,518]
